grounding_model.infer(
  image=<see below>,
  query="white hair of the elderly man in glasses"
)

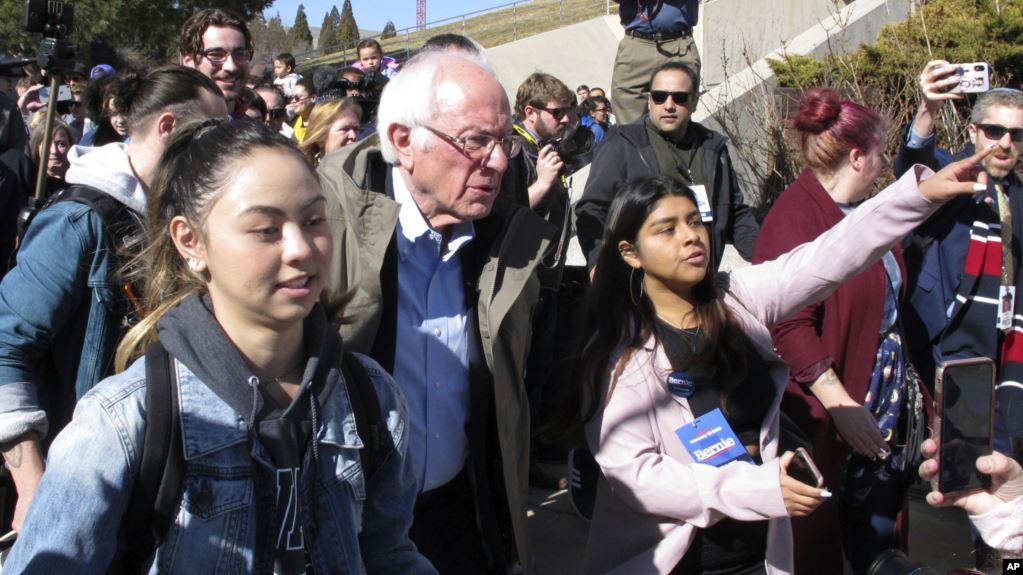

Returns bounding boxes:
[376,50,497,164]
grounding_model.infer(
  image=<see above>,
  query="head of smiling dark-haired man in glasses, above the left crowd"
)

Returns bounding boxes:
[179,8,253,120]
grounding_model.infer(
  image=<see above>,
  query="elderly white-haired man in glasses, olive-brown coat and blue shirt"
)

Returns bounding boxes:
[319,51,553,573]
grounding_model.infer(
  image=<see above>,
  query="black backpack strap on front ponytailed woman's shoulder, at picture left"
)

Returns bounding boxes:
[110,341,185,573]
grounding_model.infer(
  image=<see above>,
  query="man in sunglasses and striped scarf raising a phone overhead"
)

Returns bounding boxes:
[894,60,1023,565]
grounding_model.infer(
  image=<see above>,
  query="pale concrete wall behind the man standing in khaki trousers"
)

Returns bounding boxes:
[487,0,913,268]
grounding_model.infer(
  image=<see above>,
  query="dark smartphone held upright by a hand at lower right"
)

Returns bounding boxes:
[934,357,994,494]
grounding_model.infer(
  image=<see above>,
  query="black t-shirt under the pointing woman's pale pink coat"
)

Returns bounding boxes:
[657,320,774,575]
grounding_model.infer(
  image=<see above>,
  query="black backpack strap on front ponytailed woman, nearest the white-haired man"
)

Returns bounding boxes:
[341,350,394,478]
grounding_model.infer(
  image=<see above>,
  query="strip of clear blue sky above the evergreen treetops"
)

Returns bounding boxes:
[263,0,515,31]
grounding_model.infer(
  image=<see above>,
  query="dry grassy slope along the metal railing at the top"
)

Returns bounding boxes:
[296,0,618,69]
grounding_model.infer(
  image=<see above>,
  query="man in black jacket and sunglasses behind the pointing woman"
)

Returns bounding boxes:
[576,61,760,268]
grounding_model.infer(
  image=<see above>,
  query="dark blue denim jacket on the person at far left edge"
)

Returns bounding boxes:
[0,202,121,442]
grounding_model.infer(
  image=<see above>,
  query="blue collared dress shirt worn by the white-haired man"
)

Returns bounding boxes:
[393,168,475,492]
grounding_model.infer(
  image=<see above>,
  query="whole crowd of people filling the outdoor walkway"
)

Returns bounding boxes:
[0,0,1023,575]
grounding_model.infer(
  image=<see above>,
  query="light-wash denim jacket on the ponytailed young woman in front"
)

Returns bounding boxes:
[4,357,436,575]
